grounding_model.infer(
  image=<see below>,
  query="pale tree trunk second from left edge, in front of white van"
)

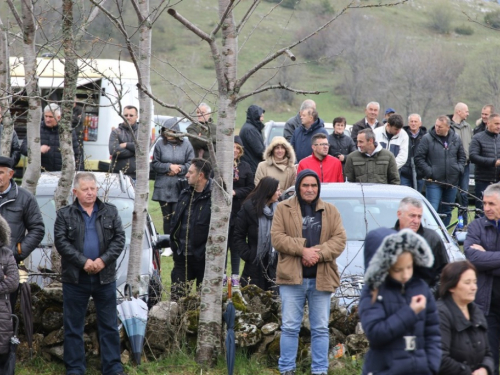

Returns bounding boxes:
[7,0,42,194]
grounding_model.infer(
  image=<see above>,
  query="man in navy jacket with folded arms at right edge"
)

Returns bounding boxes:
[464,183,500,375]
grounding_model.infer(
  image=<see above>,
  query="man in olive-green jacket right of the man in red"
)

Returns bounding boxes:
[344,129,401,185]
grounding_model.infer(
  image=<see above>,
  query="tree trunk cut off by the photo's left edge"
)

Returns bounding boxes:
[0,19,14,157]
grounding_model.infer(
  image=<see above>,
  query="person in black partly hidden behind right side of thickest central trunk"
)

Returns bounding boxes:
[229,136,255,286]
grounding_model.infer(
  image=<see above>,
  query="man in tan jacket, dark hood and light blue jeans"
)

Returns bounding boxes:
[271,169,346,375]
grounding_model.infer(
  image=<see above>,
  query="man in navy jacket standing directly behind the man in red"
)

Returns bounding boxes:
[290,108,328,163]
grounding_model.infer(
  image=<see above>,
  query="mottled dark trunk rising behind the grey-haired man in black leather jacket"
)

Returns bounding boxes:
[54,0,78,210]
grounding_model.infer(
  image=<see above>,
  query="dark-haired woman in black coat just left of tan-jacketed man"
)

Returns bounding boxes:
[233,177,281,290]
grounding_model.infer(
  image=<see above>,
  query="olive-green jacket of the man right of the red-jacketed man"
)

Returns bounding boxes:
[344,145,401,185]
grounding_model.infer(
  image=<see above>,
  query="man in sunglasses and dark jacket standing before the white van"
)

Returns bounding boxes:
[109,105,139,180]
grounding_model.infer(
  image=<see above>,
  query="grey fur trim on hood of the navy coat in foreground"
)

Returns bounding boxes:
[365,229,434,290]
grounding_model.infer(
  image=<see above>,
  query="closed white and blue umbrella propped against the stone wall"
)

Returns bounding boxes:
[117,284,148,365]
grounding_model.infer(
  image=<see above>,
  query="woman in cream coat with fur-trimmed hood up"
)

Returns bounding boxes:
[255,136,297,191]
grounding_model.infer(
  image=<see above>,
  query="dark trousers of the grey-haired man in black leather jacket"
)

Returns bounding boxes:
[63,272,123,375]
